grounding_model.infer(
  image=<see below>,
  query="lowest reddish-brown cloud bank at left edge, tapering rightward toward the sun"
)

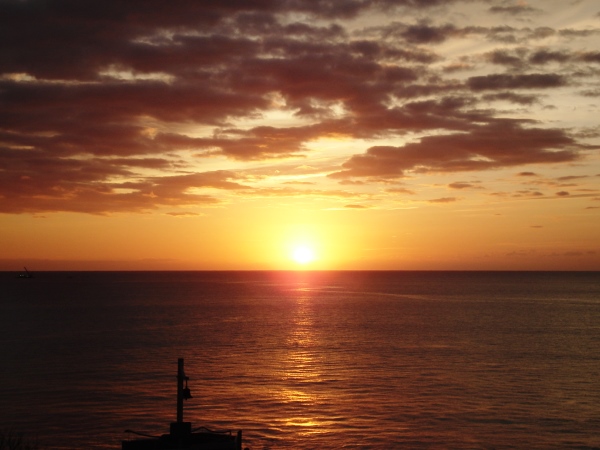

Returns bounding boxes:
[0,159,246,214]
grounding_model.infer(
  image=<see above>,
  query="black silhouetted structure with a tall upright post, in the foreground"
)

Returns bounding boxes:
[122,358,242,450]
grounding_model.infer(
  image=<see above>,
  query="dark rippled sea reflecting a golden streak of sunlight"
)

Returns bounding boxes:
[0,272,600,450]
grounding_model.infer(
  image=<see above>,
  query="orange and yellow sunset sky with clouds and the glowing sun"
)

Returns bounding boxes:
[0,0,600,271]
